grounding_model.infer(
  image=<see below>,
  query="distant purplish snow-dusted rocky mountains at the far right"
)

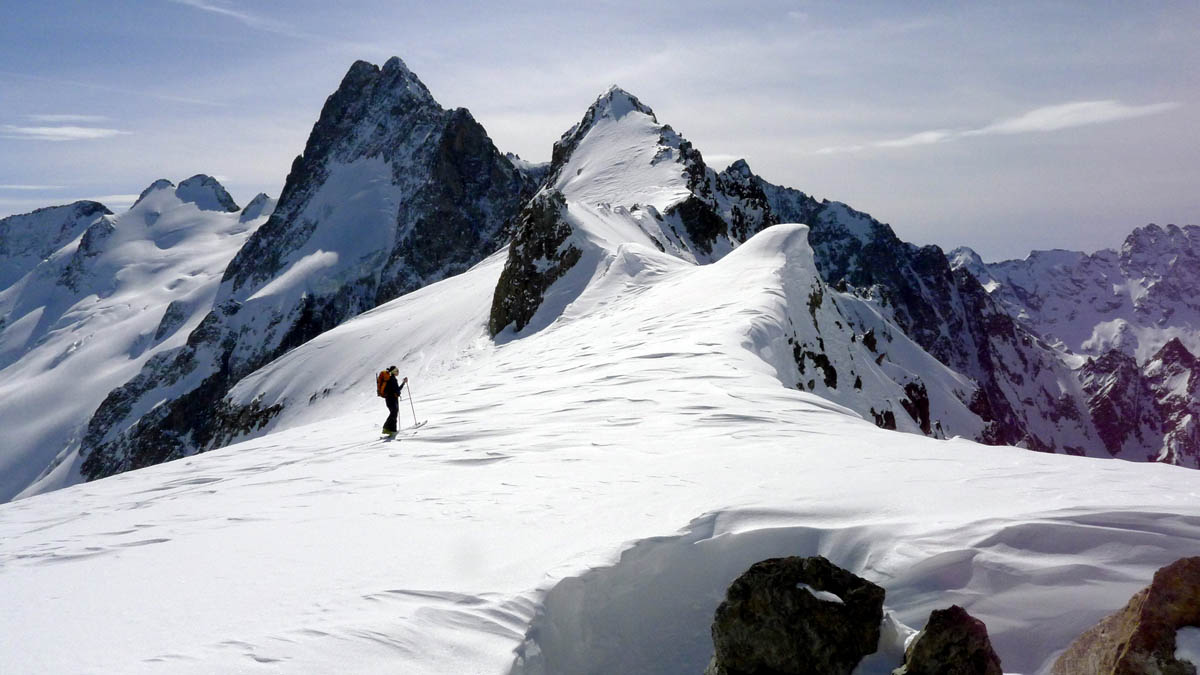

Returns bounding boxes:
[950,225,1200,467]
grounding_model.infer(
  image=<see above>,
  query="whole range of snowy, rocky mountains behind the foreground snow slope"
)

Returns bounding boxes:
[0,58,1200,500]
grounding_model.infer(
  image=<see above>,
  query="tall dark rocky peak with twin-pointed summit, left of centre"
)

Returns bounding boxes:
[83,58,534,478]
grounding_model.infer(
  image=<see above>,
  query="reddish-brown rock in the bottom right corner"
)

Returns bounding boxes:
[1050,557,1200,675]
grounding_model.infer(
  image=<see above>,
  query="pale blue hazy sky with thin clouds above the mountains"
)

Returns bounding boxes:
[0,0,1200,259]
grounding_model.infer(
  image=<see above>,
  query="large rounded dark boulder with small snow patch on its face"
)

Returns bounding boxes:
[706,556,883,675]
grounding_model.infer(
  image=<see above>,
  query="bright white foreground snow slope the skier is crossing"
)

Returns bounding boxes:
[0,226,1200,674]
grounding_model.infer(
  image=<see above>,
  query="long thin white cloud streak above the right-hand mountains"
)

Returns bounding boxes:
[816,101,1180,155]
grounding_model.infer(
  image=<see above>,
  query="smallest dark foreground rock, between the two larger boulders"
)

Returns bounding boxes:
[893,605,1003,675]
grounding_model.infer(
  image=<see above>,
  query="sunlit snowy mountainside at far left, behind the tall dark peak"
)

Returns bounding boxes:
[0,175,270,501]
